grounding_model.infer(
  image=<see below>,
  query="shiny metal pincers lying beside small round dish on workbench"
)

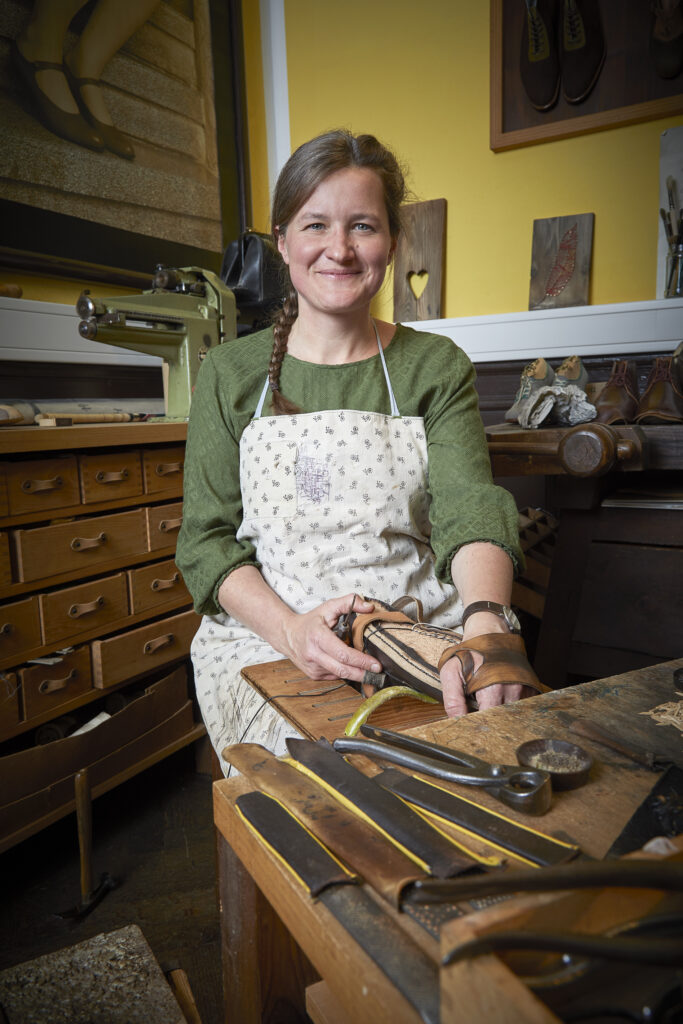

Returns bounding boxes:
[333,725,552,814]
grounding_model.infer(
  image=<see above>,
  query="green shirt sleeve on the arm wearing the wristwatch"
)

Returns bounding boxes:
[425,345,524,583]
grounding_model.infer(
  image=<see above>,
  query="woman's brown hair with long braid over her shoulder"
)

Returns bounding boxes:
[268,129,405,416]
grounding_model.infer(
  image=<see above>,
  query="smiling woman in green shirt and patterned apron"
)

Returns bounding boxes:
[176,131,535,770]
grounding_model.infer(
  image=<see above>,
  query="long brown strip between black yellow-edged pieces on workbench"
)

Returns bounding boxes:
[223,743,436,907]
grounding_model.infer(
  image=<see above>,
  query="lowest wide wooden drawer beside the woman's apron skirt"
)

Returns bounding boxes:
[92,611,200,689]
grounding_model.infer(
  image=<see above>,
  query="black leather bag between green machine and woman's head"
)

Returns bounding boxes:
[220,230,285,311]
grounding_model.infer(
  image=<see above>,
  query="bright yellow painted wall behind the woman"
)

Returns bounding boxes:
[274,0,683,318]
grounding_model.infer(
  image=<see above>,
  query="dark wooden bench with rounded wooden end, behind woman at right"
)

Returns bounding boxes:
[486,423,683,687]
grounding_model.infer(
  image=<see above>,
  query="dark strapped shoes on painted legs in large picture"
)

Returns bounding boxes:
[11,41,135,160]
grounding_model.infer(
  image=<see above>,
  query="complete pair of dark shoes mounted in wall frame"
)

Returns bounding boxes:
[519,0,606,111]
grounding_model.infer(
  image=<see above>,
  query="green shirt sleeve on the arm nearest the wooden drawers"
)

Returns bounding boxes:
[176,353,258,615]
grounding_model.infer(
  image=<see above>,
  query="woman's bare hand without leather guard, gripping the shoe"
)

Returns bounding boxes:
[283,594,382,682]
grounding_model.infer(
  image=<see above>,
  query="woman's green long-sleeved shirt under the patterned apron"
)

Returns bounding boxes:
[176,325,522,614]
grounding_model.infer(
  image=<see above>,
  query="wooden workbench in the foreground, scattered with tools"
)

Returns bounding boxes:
[214,658,683,1024]
